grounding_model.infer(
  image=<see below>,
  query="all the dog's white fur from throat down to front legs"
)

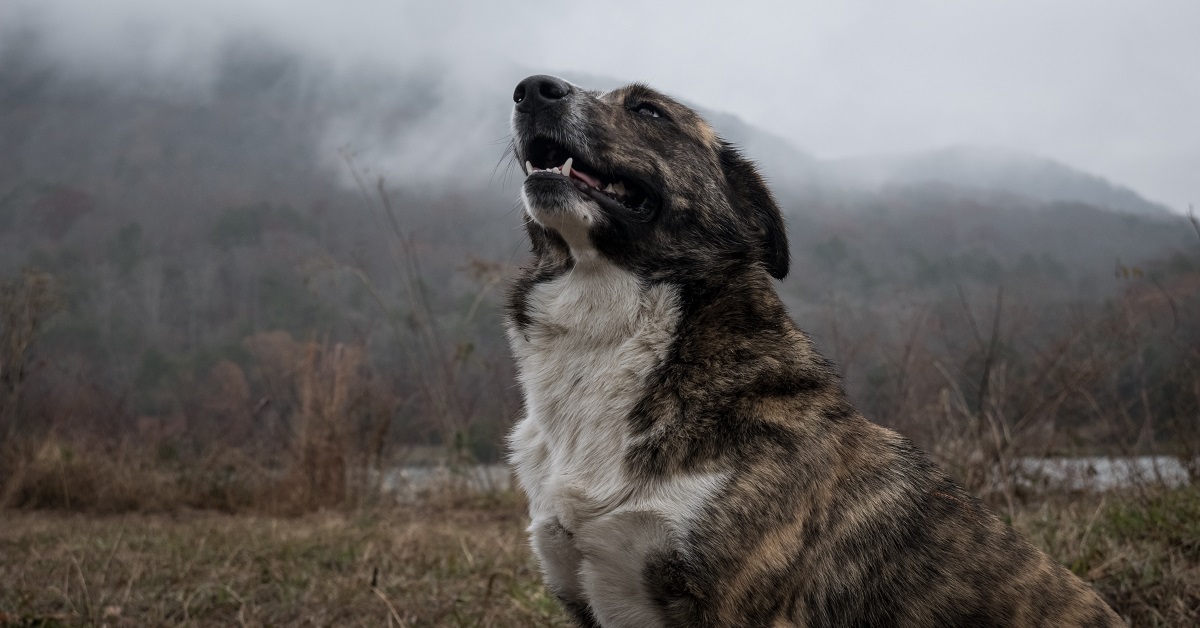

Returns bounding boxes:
[509,225,727,626]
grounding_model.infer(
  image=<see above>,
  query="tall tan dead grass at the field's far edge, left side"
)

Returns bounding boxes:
[0,334,395,514]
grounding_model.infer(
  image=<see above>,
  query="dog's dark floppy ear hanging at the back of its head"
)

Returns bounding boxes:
[720,143,791,279]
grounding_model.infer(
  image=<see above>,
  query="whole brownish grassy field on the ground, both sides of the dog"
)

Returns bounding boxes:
[0,488,1200,627]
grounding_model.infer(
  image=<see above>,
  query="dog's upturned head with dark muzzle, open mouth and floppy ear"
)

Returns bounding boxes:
[512,76,788,281]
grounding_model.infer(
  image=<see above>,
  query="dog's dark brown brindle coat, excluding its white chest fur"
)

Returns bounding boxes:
[508,76,1124,627]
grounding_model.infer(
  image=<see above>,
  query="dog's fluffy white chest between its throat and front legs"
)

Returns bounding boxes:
[509,263,679,519]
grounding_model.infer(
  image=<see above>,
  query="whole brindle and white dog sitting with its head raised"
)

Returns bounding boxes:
[508,76,1123,628]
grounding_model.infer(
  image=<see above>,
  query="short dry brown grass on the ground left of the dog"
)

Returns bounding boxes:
[0,495,566,627]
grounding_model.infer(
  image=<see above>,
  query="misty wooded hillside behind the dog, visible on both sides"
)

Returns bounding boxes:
[0,37,1200,470]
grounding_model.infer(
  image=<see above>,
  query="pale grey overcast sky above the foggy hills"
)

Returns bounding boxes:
[0,0,1200,211]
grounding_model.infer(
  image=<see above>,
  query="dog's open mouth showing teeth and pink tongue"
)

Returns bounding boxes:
[524,138,659,216]
